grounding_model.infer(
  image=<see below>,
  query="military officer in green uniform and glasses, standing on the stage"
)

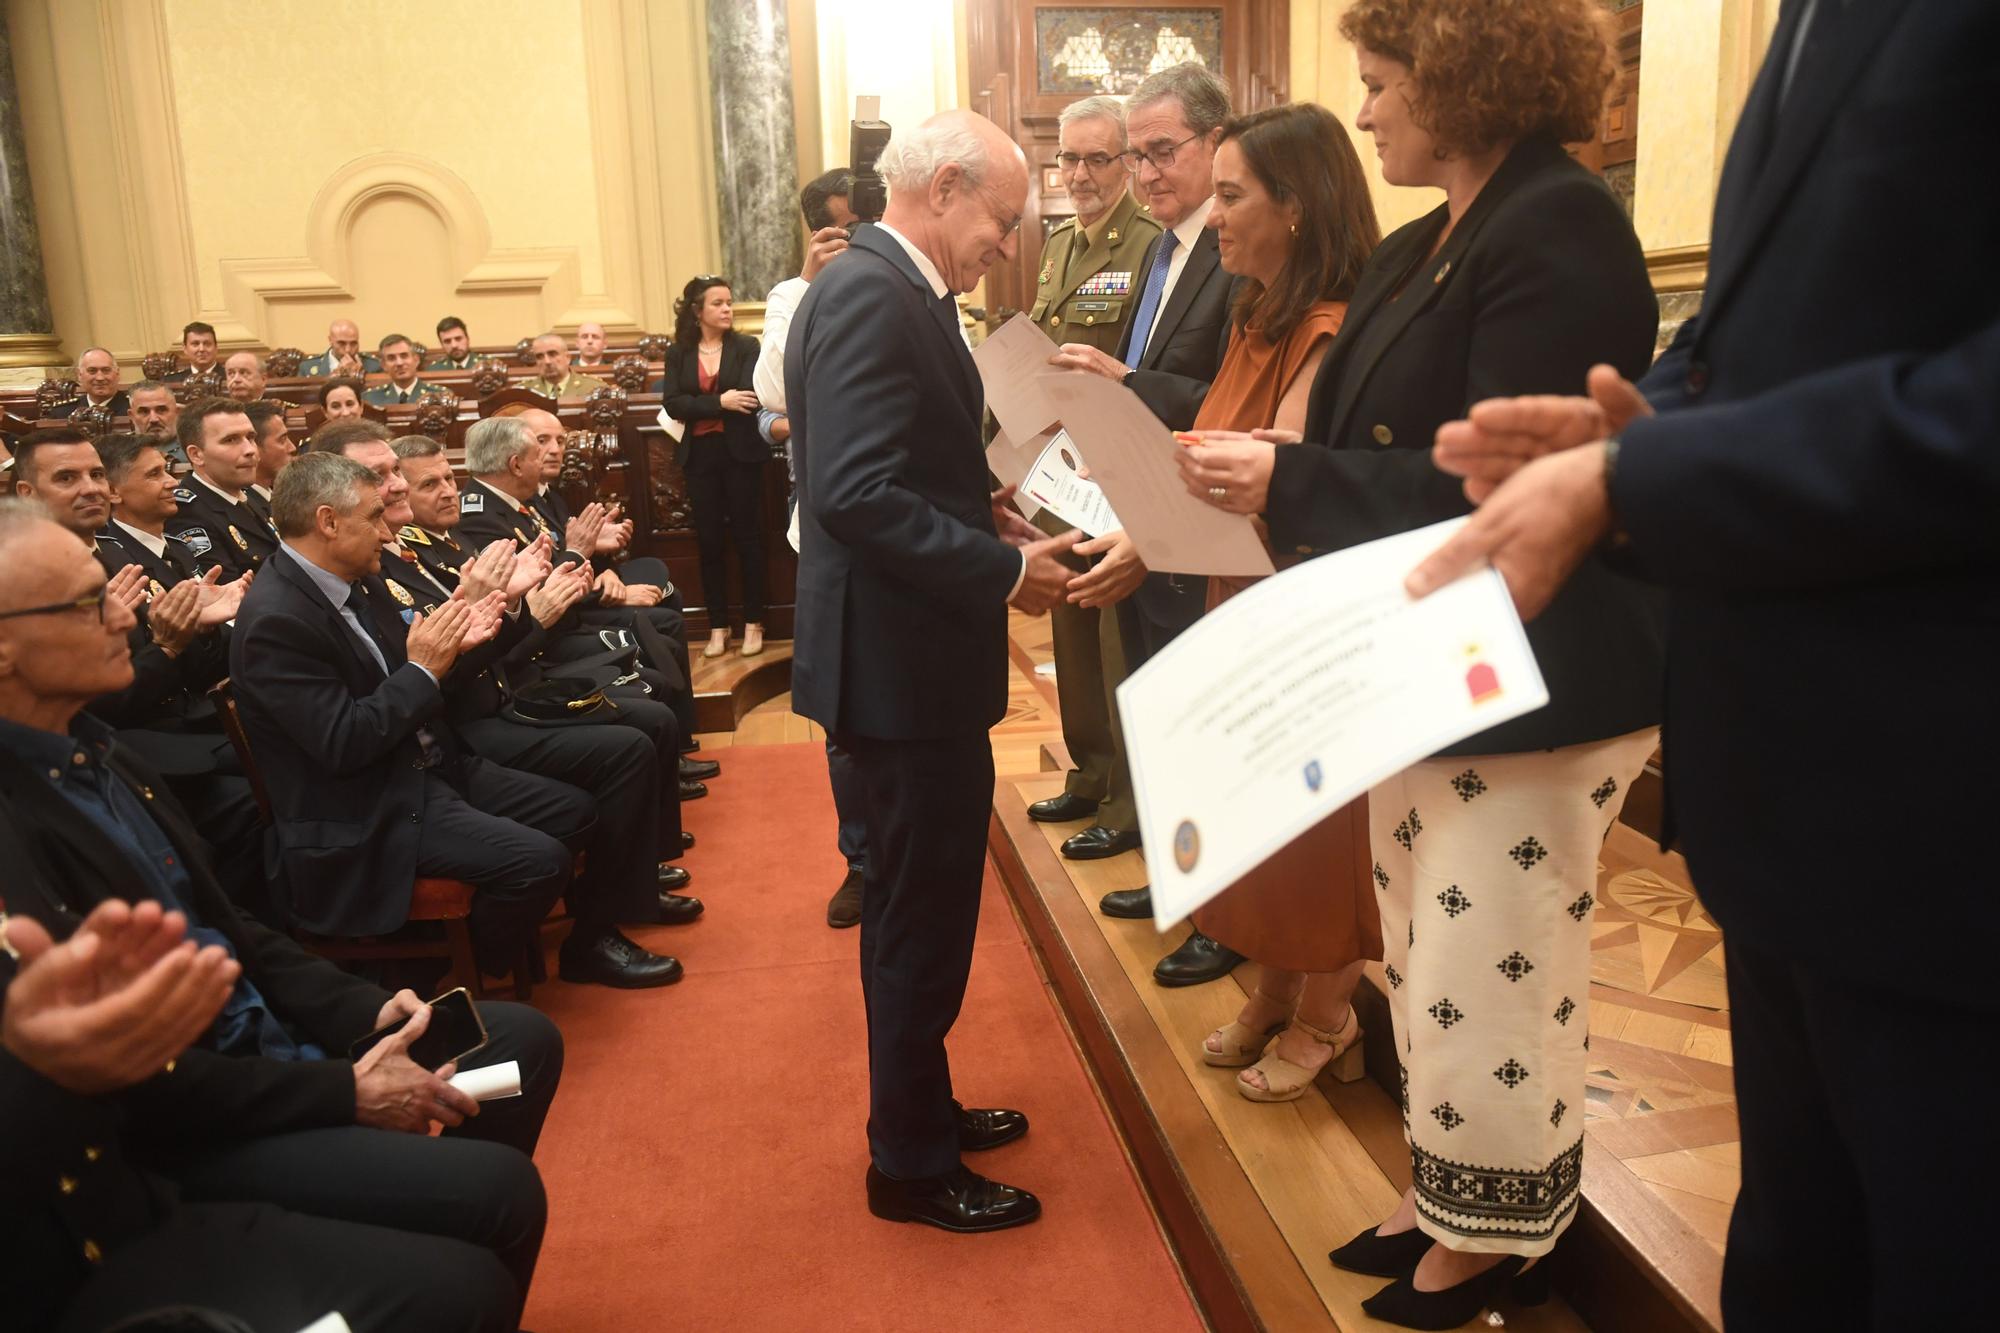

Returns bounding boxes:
[1028,96,1160,861]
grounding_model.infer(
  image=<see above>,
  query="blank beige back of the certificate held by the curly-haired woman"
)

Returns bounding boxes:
[1036,370,1272,576]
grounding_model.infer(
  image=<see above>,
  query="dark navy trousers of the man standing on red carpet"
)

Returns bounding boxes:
[840,731,994,1179]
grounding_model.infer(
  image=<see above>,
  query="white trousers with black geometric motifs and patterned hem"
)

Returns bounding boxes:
[1368,729,1658,1255]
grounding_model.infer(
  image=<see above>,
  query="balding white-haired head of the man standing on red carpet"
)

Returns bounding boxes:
[876,110,1028,292]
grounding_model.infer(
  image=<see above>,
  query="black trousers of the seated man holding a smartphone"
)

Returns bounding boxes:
[138,1001,562,1327]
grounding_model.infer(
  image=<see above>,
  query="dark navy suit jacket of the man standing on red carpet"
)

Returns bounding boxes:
[784,226,1020,741]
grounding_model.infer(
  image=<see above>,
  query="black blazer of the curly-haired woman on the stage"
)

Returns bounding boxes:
[1266,138,1664,755]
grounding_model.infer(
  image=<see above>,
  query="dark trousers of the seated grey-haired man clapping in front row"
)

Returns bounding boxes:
[416,755,596,977]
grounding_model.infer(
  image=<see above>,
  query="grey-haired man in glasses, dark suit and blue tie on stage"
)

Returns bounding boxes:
[1054,64,1242,987]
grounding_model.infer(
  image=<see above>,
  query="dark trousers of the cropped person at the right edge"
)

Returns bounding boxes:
[1722,940,2000,1333]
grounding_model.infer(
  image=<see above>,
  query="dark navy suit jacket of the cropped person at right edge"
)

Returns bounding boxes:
[1612,0,2000,984]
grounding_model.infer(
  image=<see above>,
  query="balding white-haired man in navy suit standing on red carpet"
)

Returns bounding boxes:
[784,112,1076,1231]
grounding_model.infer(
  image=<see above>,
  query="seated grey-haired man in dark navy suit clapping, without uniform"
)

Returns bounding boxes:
[230,452,596,977]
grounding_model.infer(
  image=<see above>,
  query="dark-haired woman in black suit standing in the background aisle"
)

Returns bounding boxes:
[654,274,770,656]
